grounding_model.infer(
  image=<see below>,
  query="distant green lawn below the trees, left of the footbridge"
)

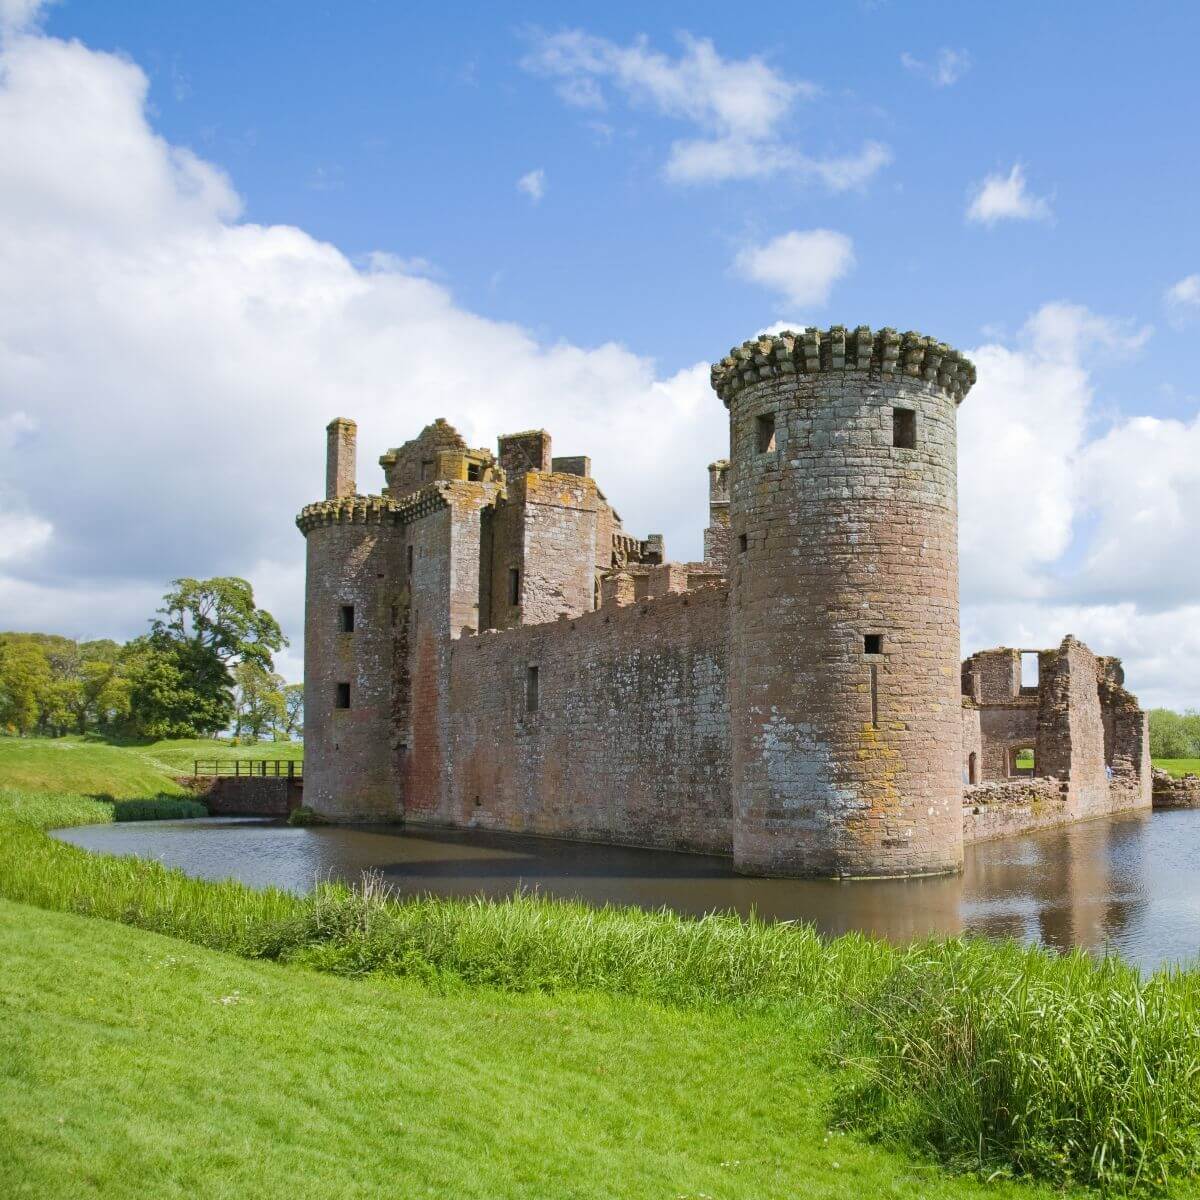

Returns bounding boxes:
[0,738,304,799]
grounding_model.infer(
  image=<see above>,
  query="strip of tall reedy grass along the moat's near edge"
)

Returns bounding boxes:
[0,787,1200,1194]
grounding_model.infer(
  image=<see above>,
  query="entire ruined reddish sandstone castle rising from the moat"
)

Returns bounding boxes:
[298,326,1150,877]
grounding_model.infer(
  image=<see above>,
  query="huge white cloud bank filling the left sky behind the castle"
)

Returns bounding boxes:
[0,28,726,668]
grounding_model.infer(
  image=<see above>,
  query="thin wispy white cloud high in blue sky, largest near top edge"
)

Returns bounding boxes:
[522,30,892,191]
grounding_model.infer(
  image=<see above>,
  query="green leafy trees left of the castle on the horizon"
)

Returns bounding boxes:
[0,576,304,740]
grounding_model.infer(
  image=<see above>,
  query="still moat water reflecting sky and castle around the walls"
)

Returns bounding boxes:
[56,811,1200,971]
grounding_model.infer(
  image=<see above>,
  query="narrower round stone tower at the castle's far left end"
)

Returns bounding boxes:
[296,496,402,821]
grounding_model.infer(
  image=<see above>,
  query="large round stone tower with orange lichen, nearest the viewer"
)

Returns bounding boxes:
[713,326,974,877]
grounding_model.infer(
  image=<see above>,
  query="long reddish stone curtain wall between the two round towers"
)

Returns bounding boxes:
[436,587,732,853]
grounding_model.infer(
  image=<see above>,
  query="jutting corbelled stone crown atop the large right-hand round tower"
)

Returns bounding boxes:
[712,325,976,407]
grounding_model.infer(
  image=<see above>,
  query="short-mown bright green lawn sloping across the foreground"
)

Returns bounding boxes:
[0,901,1062,1200]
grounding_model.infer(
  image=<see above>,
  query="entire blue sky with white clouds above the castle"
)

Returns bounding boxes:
[0,0,1200,706]
